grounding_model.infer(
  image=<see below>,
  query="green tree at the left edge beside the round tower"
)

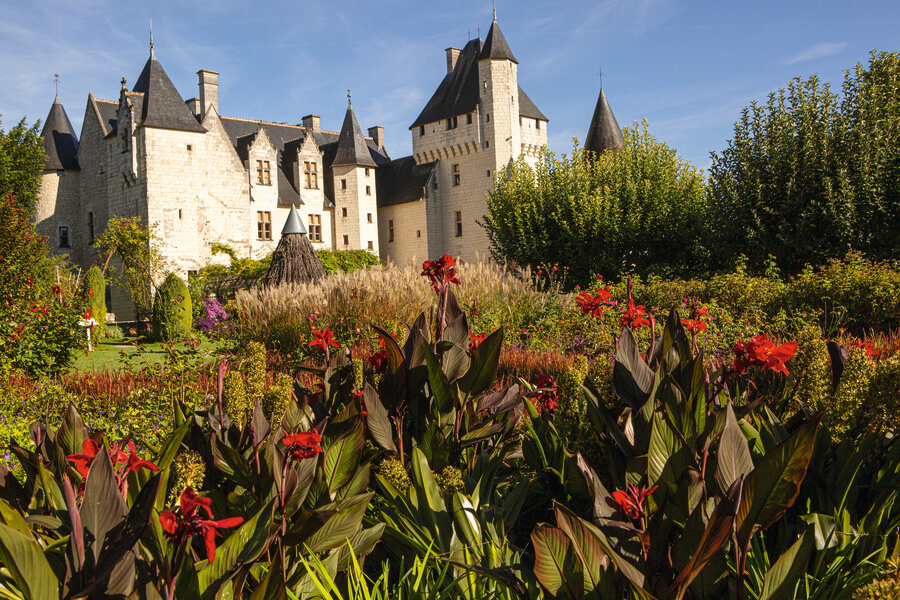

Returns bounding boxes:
[0,119,44,213]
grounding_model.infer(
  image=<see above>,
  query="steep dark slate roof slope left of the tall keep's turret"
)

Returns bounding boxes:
[409,40,481,129]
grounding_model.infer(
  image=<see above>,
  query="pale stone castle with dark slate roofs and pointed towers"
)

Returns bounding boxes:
[35,17,621,320]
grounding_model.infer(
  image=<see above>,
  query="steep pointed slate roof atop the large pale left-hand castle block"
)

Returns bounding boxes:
[132,51,206,131]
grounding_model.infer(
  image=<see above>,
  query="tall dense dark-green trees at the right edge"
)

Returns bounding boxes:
[710,52,900,273]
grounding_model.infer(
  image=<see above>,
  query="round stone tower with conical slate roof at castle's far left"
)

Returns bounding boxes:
[34,96,86,254]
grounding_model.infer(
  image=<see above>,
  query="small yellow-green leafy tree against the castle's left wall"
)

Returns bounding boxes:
[94,217,166,314]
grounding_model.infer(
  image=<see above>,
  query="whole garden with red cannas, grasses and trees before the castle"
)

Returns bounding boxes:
[0,54,900,600]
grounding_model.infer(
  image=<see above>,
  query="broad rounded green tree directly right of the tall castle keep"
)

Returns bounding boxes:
[484,121,706,285]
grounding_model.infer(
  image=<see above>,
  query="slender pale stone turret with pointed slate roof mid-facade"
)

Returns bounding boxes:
[331,91,378,254]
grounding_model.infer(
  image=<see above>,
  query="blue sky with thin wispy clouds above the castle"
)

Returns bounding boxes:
[0,0,900,167]
